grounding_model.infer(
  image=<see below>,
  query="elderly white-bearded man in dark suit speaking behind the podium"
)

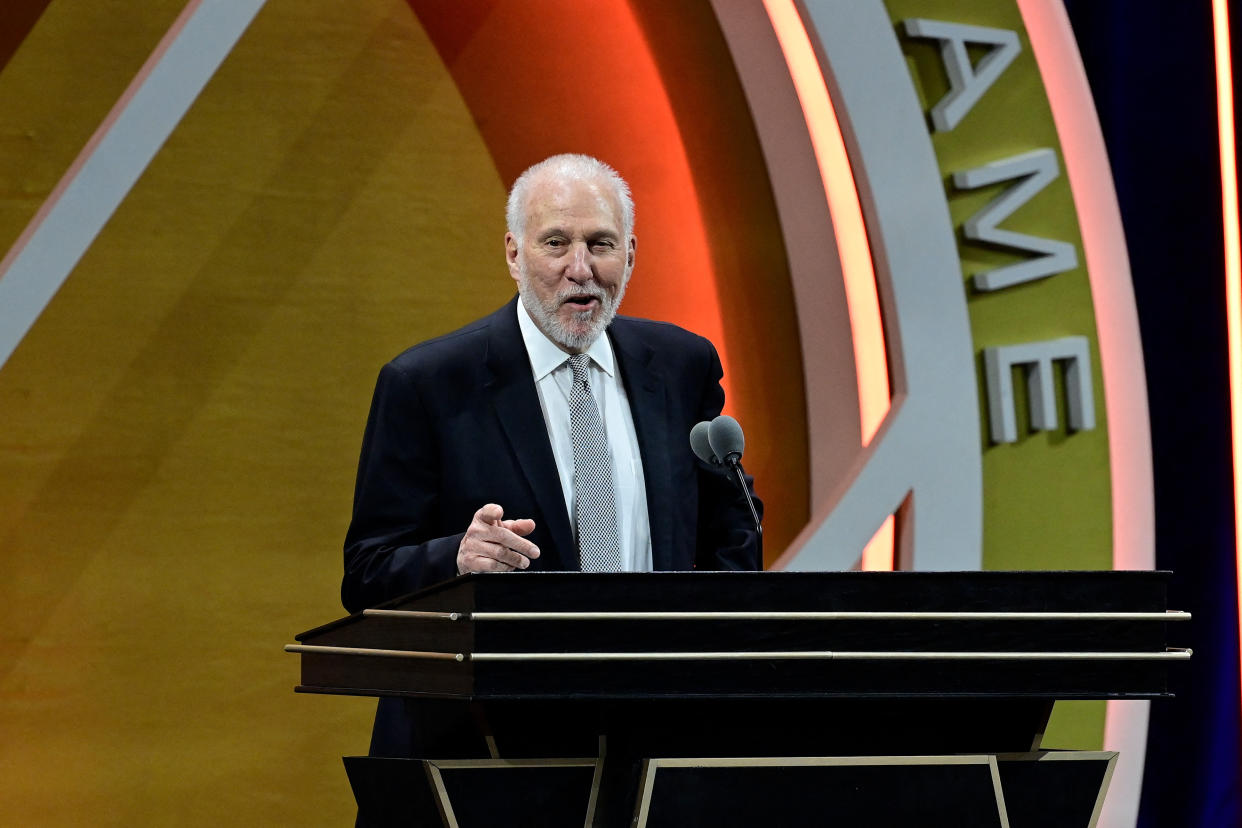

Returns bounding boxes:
[342,155,761,755]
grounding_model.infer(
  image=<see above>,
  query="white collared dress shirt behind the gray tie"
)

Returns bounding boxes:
[514,300,651,572]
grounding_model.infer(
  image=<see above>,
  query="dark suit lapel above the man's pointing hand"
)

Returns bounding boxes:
[486,299,579,570]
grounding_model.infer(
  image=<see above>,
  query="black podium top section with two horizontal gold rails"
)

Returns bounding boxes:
[287,571,1190,699]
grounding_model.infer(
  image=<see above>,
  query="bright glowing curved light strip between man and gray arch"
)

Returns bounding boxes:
[764,0,894,570]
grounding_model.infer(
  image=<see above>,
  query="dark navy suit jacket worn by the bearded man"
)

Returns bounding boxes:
[342,297,763,612]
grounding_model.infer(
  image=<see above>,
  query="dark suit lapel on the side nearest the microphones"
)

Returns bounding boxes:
[609,318,673,571]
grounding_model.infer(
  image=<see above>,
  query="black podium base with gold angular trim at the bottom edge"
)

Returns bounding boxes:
[345,751,1117,828]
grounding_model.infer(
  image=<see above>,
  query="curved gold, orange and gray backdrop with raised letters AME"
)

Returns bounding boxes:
[0,0,1212,824]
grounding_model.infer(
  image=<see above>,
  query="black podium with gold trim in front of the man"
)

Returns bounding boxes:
[287,572,1190,828]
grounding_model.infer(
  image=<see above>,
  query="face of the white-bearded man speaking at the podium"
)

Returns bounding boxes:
[504,175,635,354]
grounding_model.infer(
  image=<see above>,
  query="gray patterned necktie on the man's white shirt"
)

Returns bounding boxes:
[566,354,621,572]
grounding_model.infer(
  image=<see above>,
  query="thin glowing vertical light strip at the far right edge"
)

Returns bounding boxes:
[1212,0,1242,734]
